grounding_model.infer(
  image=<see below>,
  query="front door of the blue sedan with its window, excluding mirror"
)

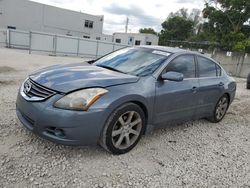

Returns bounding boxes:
[154,55,199,126]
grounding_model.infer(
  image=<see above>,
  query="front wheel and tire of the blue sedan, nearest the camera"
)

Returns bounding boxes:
[100,103,145,155]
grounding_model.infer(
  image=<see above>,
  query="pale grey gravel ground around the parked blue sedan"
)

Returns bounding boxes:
[0,49,250,187]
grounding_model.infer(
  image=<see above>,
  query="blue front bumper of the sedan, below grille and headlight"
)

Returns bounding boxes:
[16,93,111,145]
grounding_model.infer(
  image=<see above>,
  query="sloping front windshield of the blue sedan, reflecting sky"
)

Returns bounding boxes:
[95,48,171,76]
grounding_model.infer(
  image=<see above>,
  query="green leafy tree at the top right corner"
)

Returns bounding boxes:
[203,0,250,51]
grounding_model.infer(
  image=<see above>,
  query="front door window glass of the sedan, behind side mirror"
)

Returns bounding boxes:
[164,55,195,78]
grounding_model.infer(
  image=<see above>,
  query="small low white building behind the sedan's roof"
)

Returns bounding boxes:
[113,33,159,45]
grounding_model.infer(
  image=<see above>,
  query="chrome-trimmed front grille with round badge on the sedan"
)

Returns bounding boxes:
[21,79,56,101]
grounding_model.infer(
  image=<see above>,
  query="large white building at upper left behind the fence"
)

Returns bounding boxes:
[0,0,106,42]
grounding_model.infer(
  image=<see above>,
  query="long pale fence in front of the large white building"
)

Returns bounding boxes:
[0,30,131,57]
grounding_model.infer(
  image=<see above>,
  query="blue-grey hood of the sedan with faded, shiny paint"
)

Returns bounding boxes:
[30,63,139,93]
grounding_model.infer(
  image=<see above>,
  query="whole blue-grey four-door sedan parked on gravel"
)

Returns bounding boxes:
[16,46,236,154]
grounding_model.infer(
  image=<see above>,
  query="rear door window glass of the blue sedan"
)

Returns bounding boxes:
[197,56,221,77]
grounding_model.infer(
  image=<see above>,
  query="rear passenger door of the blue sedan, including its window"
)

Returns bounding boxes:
[196,55,224,117]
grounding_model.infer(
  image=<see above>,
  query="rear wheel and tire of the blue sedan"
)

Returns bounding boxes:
[208,94,229,123]
